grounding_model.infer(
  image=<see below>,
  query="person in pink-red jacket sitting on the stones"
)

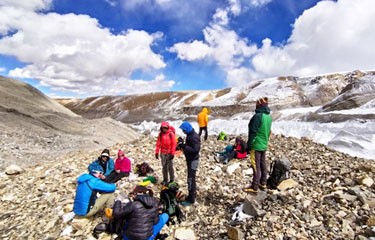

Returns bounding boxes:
[104,149,131,183]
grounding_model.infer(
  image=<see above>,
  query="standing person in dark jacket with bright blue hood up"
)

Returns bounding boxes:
[180,122,201,206]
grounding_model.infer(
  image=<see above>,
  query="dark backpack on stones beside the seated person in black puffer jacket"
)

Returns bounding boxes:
[160,182,184,226]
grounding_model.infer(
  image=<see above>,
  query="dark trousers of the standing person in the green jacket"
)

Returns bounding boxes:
[250,150,267,190]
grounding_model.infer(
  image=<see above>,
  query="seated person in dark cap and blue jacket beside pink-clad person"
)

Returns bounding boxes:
[88,149,115,180]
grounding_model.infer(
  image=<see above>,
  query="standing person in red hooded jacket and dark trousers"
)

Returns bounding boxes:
[155,122,177,185]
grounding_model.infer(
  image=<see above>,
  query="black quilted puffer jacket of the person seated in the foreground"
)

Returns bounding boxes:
[113,195,159,240]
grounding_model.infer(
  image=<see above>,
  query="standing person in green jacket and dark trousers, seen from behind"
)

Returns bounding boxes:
[243,97,272,193]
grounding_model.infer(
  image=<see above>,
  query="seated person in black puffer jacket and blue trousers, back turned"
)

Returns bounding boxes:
[112,186,169,240]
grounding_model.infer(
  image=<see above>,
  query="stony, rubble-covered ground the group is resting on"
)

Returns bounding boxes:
[0,136,375,239]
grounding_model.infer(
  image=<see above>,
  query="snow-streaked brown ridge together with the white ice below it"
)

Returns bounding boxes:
[58,71,375,159]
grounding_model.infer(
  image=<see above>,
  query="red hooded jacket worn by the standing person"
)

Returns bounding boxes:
[155,122,177,155]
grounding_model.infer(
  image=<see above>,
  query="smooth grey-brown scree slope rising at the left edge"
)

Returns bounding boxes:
[0,77,139,171]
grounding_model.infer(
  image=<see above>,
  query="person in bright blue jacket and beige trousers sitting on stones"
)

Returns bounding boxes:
[73,173,116,217]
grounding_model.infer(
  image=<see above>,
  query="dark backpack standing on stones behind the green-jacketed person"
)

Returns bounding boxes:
[267,158,292,189]
